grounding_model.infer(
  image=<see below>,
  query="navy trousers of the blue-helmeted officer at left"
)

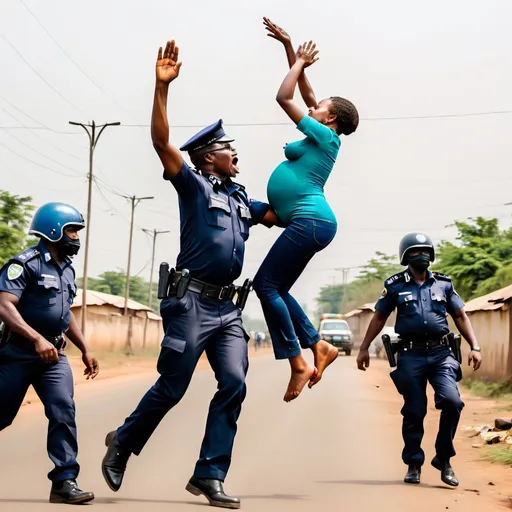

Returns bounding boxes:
[0,343,80,482]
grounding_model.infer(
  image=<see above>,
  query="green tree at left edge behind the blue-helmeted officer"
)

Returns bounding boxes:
[0,190,34,265]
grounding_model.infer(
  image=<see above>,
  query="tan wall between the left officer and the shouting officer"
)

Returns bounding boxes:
[73,306,163,350]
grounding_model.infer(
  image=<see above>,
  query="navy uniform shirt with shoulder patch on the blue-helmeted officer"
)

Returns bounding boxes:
[0,240,76,336]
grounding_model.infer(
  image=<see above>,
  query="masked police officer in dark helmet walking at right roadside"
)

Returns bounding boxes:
[357,233,482,487]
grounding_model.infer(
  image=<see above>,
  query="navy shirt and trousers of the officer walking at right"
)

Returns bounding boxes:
[375,270,464,466]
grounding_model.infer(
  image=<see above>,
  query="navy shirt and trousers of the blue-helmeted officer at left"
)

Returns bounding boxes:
[0,240,79,482]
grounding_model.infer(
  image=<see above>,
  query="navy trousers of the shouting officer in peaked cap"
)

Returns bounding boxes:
[117,291,249,480]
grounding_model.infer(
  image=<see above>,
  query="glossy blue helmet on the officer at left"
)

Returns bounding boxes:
[28,203,85,257]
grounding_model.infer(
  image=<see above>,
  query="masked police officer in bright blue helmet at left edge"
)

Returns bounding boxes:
[0,203,99,504]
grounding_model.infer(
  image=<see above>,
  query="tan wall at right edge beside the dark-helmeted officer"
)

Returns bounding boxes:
[462,309,512,381]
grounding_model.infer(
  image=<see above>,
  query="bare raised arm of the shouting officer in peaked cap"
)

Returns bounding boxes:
[151,41,183,178]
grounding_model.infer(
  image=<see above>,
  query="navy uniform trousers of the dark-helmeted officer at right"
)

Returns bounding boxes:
[391,347,464,465]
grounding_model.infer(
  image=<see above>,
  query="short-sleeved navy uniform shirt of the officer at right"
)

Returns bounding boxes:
[375,270,464,340]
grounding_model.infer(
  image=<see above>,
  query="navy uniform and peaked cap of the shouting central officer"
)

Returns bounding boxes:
[113,123,269,484]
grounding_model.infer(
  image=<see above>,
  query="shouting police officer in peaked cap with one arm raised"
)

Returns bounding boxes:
[102,41,277,508]
